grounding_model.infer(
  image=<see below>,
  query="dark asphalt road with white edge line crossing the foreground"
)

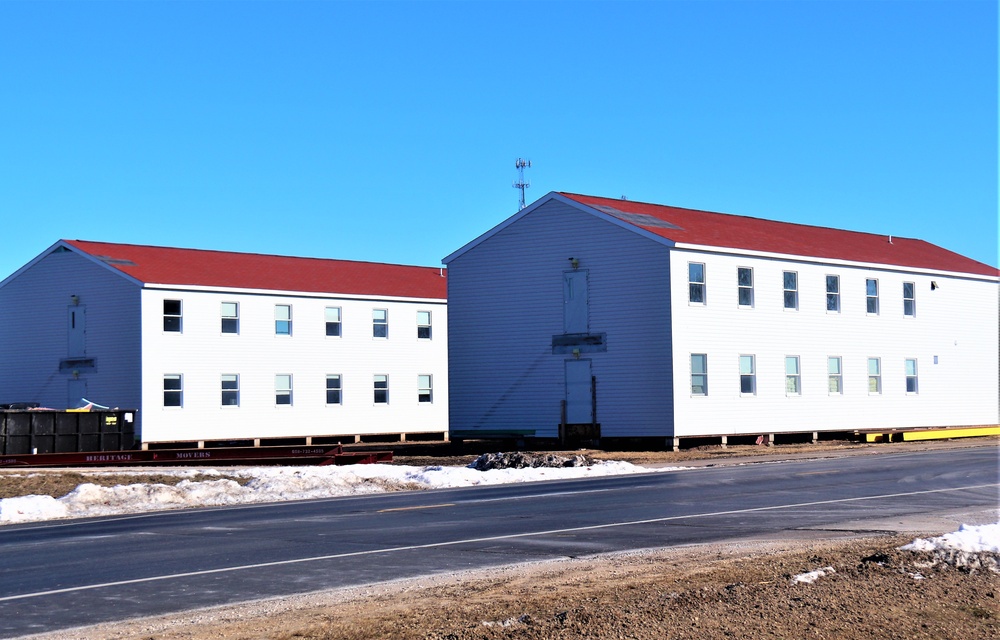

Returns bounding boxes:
[0,447,1000,638]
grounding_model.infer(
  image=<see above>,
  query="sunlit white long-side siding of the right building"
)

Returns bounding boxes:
[672,251,998,435]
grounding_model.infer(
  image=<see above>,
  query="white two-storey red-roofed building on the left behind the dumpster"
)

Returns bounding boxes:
[0,240,448,446]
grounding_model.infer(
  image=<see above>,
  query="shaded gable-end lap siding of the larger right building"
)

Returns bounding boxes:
[448,202,672,437]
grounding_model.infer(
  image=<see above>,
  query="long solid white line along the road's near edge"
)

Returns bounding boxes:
[0,483,1000,602]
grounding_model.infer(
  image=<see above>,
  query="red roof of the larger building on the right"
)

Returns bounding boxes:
[560,193,1000,276]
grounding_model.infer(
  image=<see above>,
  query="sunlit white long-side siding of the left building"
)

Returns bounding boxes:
[143,289,448,442]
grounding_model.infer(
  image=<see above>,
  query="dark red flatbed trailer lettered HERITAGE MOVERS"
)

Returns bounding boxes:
[0,444,392,469]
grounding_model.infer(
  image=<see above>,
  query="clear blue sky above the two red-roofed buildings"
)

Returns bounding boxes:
[0,0,998,278]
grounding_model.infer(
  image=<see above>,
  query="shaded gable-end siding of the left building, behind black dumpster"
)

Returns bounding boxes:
[0,252,141,420]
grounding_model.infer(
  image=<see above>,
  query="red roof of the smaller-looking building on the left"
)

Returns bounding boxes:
[64,240,447,300]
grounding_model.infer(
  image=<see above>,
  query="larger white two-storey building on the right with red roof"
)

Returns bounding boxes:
[444,193,1000,445]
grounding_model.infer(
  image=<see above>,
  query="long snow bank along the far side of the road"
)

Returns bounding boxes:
[0,462,683,524]
